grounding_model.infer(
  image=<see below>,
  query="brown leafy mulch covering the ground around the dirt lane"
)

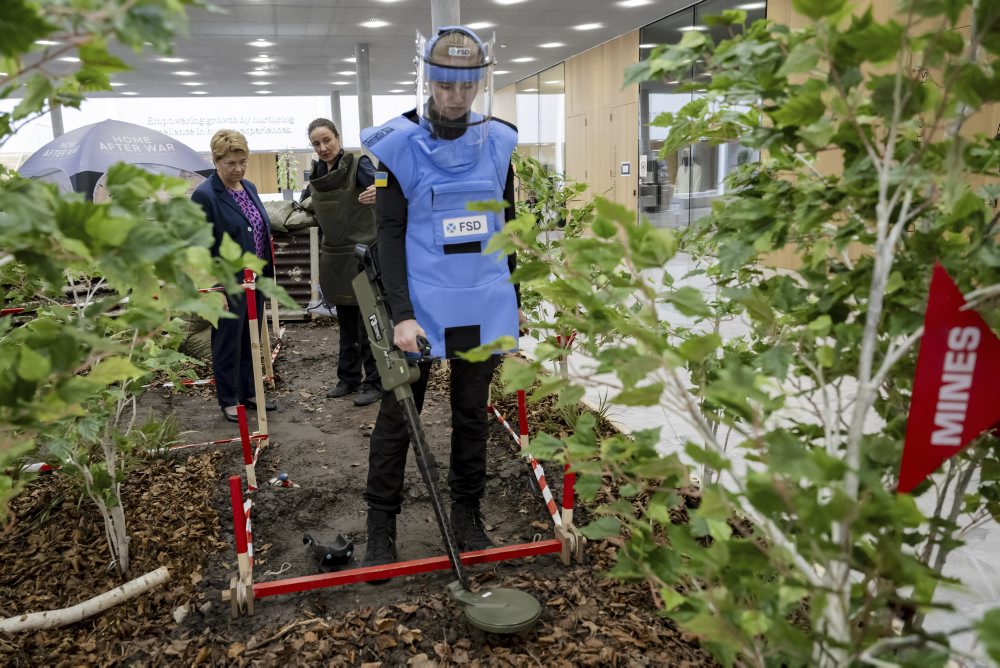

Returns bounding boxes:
[0,354,716,668]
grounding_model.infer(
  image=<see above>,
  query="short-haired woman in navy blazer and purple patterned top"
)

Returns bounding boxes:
[191,130,274,422]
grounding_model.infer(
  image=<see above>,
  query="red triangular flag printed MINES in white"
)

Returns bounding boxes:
[899,263,1000,492]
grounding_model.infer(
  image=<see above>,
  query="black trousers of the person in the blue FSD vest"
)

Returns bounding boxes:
[365,355,500,514]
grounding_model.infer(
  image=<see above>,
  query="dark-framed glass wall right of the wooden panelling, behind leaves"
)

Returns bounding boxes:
[638,0,766,227]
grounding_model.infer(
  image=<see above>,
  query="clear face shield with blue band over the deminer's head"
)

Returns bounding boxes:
[416,26,494,139]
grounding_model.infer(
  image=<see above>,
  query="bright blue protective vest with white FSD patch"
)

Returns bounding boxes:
[361,116,518,358]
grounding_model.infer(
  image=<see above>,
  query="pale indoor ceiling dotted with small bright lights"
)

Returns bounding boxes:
[86,0,693,97]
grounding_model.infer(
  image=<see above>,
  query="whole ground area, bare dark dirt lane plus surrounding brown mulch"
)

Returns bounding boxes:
[0,320,712,666]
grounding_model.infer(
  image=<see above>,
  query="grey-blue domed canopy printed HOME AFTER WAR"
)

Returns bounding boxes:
[18,120,214,201]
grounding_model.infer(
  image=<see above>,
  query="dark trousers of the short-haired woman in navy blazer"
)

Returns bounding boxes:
[212,290,264,408]
